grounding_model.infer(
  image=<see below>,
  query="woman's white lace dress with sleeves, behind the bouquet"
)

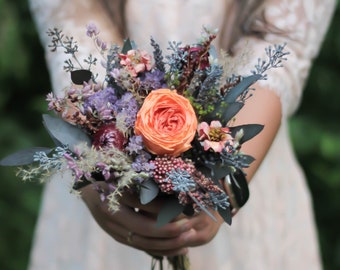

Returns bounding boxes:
[30,0,335,270]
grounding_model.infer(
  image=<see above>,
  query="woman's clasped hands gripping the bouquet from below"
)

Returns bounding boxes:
[82,182,223,256]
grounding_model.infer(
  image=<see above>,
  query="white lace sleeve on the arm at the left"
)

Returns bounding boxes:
[29,0,121,96]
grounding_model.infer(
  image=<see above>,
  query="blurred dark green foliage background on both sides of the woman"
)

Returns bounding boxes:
[0,0,340,270]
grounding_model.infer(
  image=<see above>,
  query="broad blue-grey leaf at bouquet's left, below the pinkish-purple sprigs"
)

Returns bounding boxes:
[43,114,91,151]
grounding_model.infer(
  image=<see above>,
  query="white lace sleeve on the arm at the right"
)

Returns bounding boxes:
[230,0,336,116]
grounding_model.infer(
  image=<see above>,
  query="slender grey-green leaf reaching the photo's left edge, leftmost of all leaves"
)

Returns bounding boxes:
[0,147,53,166]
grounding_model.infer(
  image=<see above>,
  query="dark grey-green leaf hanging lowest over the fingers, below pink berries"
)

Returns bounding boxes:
[157,198,184,227]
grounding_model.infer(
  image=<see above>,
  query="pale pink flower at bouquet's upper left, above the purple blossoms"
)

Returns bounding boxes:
[119,50,152,77]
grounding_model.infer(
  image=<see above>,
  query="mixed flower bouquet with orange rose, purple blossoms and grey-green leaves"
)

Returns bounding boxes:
[0,24,287,269]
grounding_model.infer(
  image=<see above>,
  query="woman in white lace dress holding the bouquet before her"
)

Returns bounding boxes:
[30,0,335,270]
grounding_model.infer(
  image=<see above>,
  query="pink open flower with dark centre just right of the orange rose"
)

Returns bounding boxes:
[197,121,233,153]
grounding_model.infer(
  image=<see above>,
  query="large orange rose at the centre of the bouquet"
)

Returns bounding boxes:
[135,89,197,156]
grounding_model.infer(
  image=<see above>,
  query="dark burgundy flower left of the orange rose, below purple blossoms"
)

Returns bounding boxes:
[93,124,127,150]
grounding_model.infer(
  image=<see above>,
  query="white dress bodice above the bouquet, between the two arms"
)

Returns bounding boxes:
[126,0,229,48]
